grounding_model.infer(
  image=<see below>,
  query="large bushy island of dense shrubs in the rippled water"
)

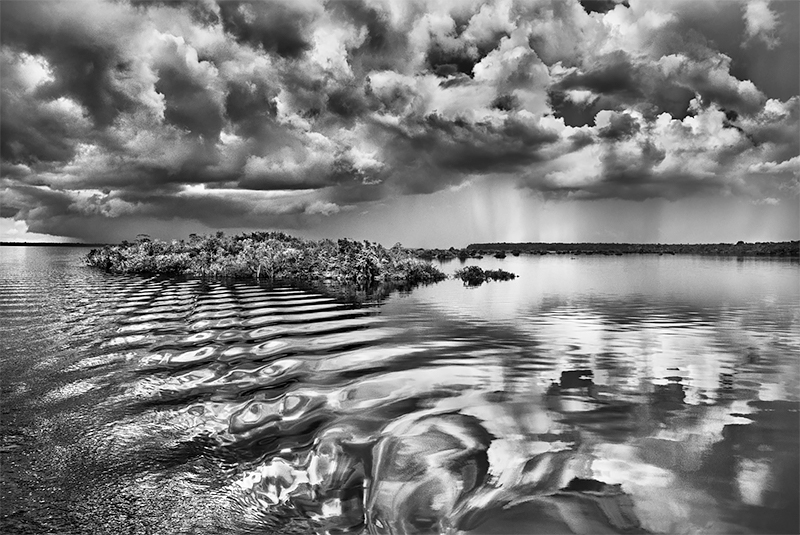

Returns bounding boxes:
[86,232,446,286]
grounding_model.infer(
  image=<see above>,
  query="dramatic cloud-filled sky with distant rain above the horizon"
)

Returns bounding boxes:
[0,0,800,247]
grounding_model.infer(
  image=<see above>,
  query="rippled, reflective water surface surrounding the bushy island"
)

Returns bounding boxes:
[0,247,800,534]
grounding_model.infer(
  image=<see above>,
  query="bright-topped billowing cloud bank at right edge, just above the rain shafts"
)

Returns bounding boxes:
[525,99,800,200]
